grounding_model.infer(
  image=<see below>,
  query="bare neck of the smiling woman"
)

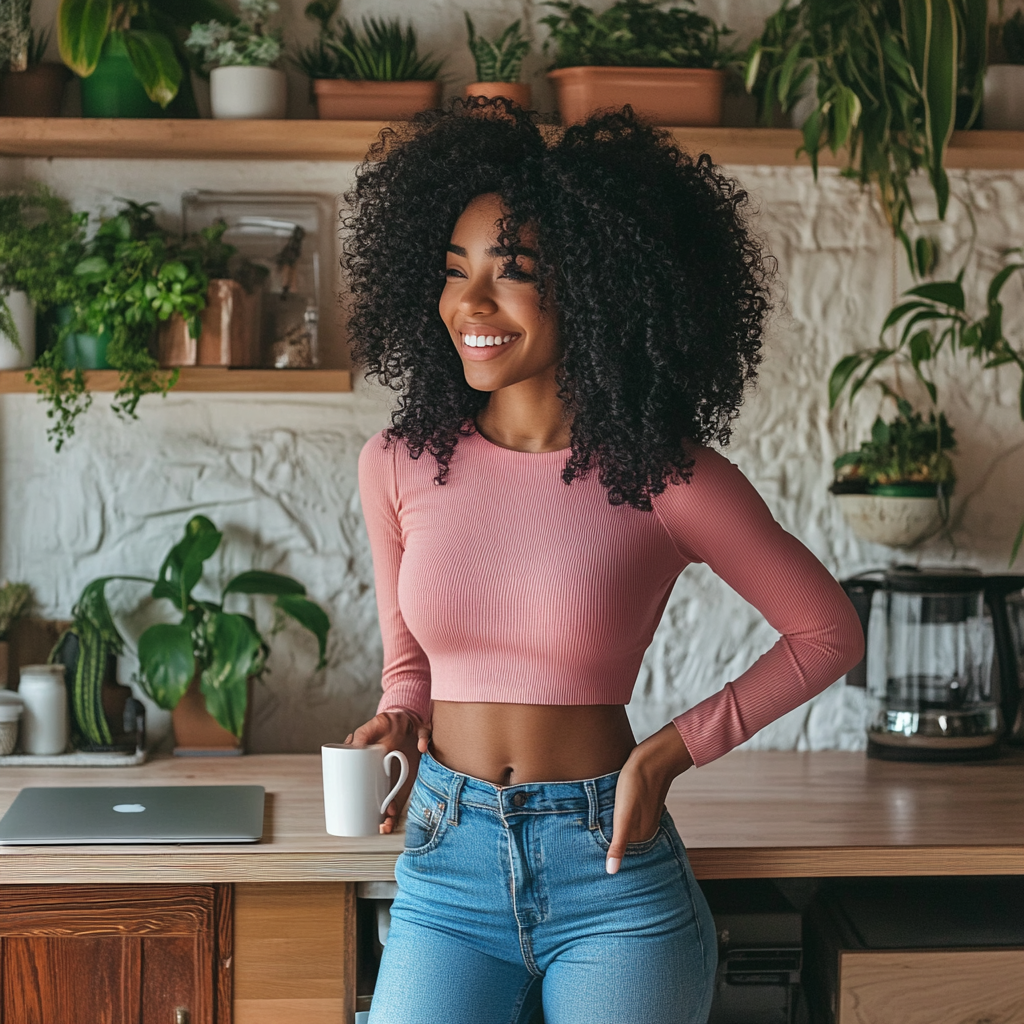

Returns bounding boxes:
[476,367,572,452]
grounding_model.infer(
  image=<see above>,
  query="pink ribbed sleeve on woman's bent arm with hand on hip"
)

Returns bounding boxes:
[654,449,863,766]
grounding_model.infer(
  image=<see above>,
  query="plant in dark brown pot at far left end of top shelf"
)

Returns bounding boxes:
[0,0,71,118]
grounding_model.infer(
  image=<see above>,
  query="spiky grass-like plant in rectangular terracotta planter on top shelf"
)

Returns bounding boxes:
[295,0,443,121]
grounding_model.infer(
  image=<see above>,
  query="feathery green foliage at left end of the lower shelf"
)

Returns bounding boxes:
[0,184,88,345]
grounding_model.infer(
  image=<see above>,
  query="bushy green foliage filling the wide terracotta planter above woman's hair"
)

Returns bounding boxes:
[541,0,736,68]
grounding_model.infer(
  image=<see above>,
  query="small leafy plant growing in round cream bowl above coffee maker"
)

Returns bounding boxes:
[833,392,956,496]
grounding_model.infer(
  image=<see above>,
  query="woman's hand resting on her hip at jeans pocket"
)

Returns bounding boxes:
[604,722,693,874]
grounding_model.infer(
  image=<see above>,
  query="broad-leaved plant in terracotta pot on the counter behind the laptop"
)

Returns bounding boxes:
[58,515,330,754]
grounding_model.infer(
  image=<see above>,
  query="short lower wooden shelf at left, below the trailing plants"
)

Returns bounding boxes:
[0,367,352,394]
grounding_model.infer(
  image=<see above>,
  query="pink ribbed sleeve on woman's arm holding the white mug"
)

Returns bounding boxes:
[359,434,430,722]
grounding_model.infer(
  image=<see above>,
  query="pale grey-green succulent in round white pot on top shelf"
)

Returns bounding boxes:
[185,0,288,119]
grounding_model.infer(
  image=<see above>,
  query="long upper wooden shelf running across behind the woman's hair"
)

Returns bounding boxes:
[0,118,1024,170]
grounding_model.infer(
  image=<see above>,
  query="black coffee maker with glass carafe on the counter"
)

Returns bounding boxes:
[843,565,1024,761]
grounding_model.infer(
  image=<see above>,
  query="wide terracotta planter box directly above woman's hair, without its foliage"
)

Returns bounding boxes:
[548,68,725,127]
